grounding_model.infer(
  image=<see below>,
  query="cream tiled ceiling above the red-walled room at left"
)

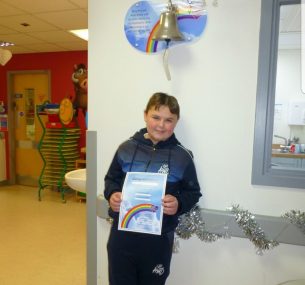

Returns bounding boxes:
[0,0,88,54]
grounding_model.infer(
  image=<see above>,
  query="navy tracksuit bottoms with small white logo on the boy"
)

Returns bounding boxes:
[107,223,174,285]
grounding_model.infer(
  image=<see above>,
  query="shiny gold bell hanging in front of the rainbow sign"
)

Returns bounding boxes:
[152,5,184,42]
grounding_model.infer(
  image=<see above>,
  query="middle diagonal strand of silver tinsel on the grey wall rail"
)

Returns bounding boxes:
[229,205,279,255]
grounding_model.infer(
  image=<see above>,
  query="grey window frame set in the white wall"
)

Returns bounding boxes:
[252,0,305,188]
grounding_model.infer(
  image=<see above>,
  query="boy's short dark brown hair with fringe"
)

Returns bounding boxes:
[145,92,180,119]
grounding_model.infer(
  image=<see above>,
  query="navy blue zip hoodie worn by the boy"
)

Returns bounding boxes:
[104,129,201,233]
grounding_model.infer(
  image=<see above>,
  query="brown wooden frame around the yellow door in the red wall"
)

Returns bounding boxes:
[7,69,51,185]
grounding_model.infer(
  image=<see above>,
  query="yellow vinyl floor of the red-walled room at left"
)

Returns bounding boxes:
[0,185,86,285]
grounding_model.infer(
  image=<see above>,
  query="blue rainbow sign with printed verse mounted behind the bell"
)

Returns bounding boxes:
[124,0,207,53]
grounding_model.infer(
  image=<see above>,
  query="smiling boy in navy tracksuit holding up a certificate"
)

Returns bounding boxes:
[104,93,201,285]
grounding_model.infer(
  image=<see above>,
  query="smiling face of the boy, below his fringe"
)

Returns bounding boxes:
[144,106,178,144]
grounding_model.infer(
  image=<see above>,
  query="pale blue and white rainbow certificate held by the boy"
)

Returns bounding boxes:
[118,172,167,235]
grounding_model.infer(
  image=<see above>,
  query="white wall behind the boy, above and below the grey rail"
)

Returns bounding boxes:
[89,0,305,285]
